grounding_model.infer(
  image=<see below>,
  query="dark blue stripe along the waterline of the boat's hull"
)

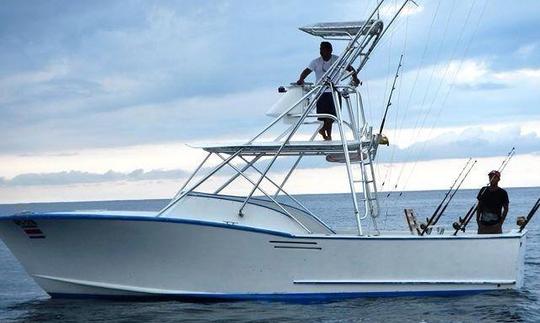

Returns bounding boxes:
[49,289,493,302]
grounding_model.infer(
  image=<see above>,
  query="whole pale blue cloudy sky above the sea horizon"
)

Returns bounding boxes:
[0,0,540,203]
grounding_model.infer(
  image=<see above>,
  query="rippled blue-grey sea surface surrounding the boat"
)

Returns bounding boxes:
[0,188,540,322]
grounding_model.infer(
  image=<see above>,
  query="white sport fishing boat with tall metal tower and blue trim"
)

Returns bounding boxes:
[0,1,527,299]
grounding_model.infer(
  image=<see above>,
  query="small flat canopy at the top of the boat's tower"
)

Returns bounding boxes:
[299,20,383,38]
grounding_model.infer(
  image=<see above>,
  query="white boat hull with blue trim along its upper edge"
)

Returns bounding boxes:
[0,215,525,299]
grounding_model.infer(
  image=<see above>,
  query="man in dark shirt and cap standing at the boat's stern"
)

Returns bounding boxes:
[476,170,509,234]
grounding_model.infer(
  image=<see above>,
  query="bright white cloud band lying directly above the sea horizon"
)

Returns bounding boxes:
[0,154,540,203]
